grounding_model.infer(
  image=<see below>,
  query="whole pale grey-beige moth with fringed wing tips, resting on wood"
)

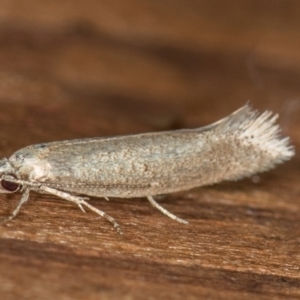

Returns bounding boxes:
[0,104,295,232]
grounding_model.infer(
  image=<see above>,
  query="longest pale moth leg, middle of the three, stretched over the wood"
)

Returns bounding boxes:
[36,186,122,234]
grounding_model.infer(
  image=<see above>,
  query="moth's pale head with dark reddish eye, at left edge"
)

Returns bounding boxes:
[0,158,22,193]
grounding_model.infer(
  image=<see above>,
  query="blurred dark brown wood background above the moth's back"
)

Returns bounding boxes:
[0,0,300,146]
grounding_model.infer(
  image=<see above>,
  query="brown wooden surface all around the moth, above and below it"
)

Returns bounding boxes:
[0,0,300,300]
